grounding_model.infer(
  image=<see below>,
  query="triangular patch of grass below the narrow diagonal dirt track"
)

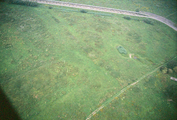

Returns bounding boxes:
[93,71,177,120]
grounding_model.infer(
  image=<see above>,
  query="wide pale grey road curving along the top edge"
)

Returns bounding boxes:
[31,0,177,31]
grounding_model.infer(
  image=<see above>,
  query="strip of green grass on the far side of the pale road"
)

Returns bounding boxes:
[62,0,177,23]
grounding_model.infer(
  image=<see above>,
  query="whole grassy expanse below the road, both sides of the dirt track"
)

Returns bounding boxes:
[0,1,177,120]
